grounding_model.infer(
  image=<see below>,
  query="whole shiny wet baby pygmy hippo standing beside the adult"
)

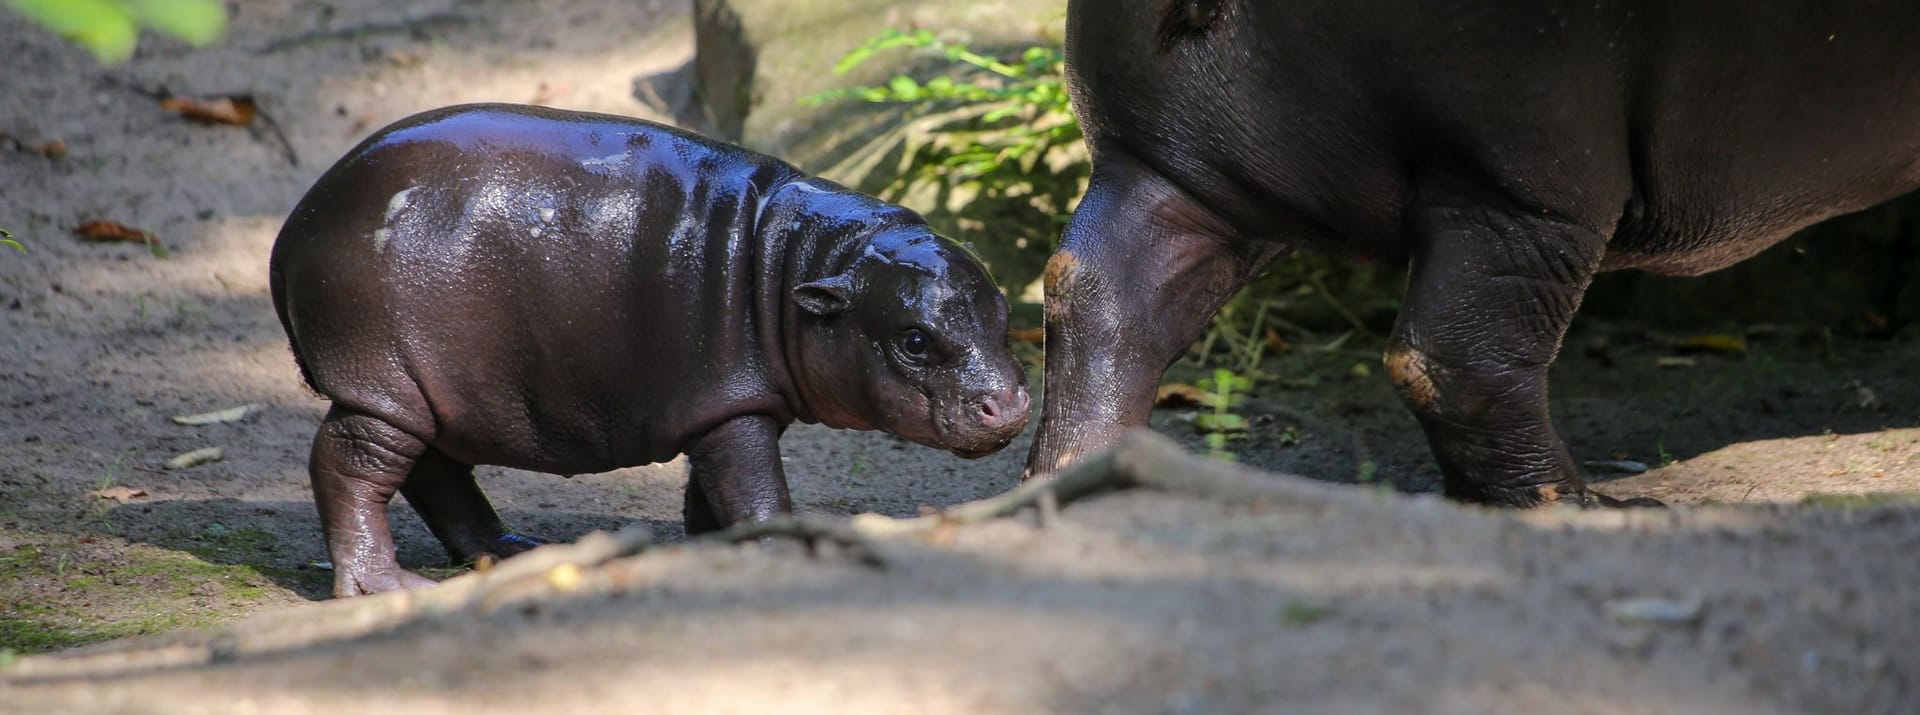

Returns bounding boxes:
[271,106,1027,596]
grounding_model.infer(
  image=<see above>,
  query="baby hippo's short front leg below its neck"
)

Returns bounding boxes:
[685,415,793,536]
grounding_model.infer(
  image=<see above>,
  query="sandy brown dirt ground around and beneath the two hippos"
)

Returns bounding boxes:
[0,0,1920,713]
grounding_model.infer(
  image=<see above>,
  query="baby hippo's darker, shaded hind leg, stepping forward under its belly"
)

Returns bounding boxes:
[399,448,545,563]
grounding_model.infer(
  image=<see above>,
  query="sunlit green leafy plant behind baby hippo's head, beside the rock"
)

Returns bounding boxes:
[801,31,1092,290]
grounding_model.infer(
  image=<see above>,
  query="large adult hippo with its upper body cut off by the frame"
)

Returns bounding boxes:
[1027,0,1920,505]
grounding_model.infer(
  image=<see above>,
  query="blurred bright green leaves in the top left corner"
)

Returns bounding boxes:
[6,0,227,63]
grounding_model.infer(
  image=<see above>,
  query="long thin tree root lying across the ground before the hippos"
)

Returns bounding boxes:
[0,429,1351,680]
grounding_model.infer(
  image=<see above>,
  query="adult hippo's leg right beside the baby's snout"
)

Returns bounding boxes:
[1023,152,1279,479]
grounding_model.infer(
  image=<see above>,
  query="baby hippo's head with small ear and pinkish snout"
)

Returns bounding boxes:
[791,225,1031,459]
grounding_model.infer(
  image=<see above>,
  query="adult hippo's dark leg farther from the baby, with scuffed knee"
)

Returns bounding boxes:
[1384,196,1658,505]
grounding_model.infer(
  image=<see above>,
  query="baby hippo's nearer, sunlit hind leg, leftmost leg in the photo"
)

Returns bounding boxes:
[309,404,434,598]
